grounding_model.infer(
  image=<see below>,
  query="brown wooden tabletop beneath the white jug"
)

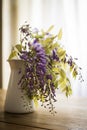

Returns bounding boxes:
[0,90,87,130]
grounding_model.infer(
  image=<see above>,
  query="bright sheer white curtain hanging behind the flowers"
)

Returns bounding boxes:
[3,0,87,96]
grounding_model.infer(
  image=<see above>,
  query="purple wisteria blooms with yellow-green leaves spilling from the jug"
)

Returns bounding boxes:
[9,24,81,114]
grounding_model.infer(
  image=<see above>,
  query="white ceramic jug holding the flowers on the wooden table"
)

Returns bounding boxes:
[5,60,34,113]
